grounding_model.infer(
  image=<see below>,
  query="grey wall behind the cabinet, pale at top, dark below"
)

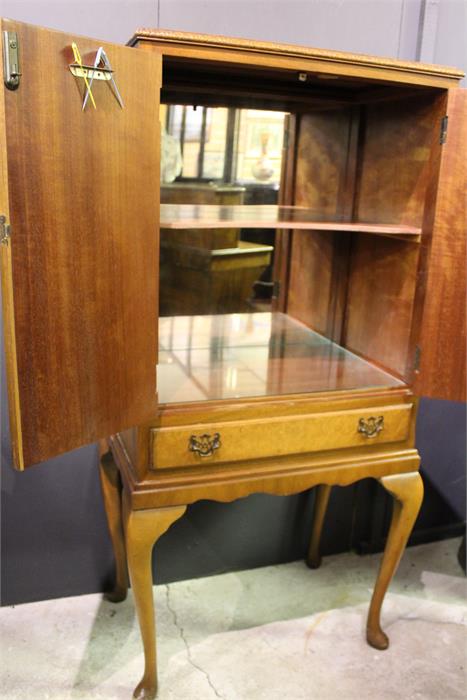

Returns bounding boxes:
[0,0,467,603]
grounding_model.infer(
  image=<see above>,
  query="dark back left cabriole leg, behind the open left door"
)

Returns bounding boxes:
[99,450,128,603]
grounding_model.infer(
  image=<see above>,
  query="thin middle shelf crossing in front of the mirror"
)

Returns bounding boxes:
[160,204,421,242]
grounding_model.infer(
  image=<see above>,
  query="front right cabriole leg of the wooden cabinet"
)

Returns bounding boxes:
[367,472,423,649]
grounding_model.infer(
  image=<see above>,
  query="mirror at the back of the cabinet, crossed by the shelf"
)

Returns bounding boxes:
[160,105,286,316]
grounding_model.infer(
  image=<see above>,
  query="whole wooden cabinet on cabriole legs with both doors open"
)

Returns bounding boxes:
[0,20,467,698]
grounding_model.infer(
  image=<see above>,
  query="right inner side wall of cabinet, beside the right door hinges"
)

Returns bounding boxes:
[343,93,445,380]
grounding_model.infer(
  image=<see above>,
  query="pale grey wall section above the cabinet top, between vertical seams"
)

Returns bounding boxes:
[160,0,418,56]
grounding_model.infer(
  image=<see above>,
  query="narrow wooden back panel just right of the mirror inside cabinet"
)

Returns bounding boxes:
[287,109,358,340]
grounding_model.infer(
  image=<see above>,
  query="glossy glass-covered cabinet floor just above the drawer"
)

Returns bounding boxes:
[158,312,405,404]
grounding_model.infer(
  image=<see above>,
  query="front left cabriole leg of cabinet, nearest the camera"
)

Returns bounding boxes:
[123,495,186,700]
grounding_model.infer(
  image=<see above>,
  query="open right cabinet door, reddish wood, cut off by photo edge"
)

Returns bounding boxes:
[414,88,467,401]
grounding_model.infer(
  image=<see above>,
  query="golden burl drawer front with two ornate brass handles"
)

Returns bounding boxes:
[150,404,412,469]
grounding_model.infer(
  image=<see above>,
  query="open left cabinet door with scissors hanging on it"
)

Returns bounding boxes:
[0,20,161,468]
